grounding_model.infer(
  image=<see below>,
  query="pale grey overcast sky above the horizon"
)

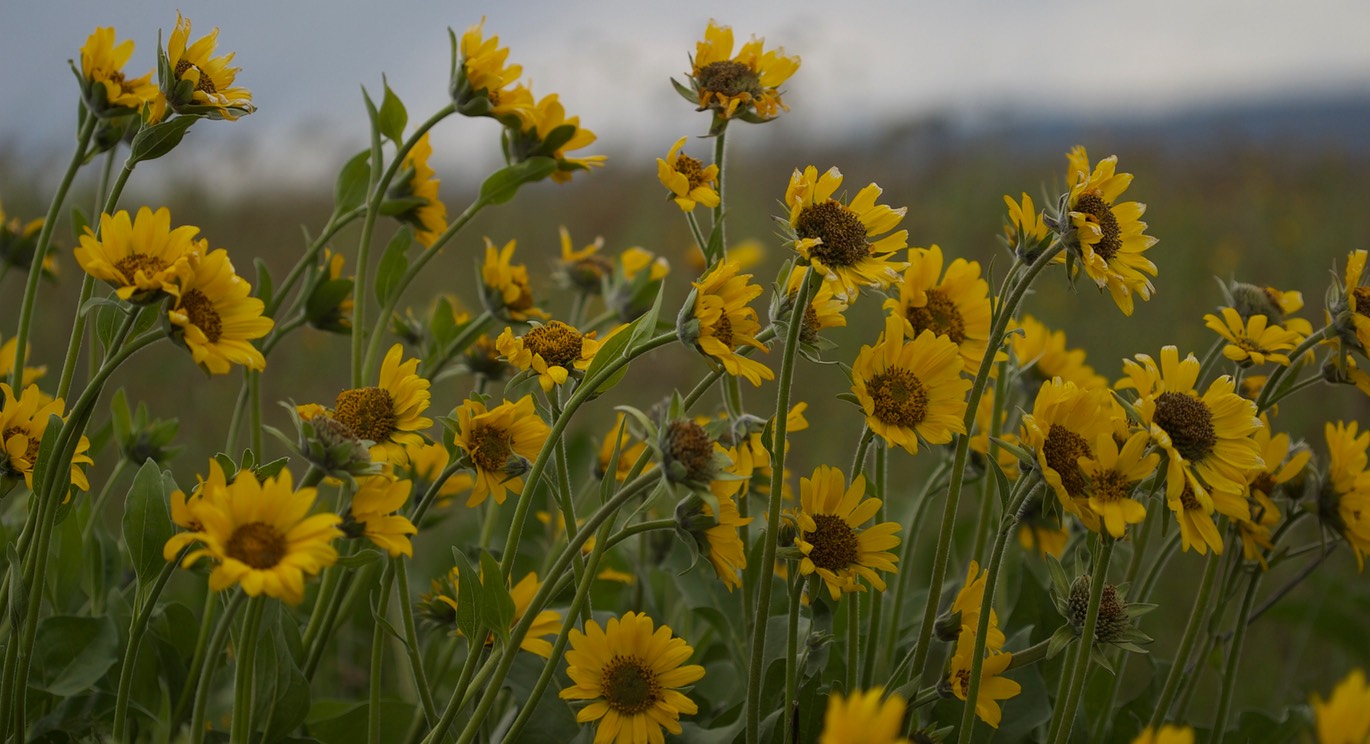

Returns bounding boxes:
[0,0,1370,191]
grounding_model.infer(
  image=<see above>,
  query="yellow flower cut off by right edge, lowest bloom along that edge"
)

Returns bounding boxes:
[1318,421,1370,569]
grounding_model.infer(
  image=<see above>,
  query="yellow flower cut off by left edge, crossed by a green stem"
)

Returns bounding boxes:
[0,382,93,497]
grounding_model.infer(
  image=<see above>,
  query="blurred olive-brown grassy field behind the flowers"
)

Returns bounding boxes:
[0,127,1370,728]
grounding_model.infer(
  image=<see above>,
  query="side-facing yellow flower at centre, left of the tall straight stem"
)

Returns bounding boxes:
[682,260,775,385]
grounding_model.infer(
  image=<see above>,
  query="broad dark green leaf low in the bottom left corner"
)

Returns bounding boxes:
[29,615,119,697]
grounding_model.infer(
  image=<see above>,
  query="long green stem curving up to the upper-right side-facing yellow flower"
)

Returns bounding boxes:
[912,243,1064,678]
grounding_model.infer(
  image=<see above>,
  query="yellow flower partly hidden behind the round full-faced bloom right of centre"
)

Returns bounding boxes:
[885,245,989,373]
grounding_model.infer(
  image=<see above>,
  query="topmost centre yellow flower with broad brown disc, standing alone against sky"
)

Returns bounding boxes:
[689,19,799,129]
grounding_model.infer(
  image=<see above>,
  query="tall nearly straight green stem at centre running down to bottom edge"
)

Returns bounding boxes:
[745,269,805,744]
